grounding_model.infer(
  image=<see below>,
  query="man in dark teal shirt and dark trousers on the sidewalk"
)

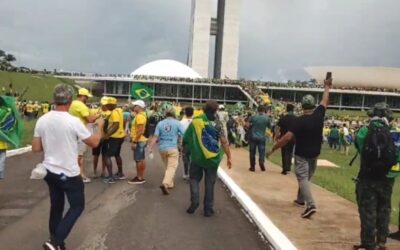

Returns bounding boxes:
[248,105,271,172]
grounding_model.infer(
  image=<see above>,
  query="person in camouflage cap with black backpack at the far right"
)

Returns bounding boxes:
[354,103,394,250]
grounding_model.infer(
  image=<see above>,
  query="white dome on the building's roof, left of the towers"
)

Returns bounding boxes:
[131,60,202,79]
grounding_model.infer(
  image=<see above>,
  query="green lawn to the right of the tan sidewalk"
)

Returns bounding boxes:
[267,144,400,225]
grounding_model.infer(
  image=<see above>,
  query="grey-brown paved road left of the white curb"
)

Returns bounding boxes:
[0,143,268,250]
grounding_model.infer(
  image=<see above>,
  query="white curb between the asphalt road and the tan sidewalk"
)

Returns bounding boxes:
[218,168,297,250]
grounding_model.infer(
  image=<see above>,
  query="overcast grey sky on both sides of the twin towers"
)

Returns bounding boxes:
[0,0,400,81]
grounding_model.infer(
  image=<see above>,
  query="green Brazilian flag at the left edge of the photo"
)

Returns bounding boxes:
[0,96,23,148]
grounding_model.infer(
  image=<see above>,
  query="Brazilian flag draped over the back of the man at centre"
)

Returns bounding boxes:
[183,114,223,169]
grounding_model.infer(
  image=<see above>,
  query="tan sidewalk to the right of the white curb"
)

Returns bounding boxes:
[222,148,400,250]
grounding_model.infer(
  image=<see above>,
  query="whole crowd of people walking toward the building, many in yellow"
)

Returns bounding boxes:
[0,79,400,250]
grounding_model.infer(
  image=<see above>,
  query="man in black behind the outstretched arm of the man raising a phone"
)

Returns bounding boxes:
[276,103,296,175]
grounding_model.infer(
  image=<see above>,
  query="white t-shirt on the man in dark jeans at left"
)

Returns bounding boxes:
[33,111,91,177]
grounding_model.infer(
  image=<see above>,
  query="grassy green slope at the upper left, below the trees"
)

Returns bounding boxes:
[0,71,74,101]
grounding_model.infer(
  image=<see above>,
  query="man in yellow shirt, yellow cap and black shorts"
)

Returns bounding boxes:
[103,97,126,184]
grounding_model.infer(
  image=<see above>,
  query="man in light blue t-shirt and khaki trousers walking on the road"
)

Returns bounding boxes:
[149,106,185,195]
